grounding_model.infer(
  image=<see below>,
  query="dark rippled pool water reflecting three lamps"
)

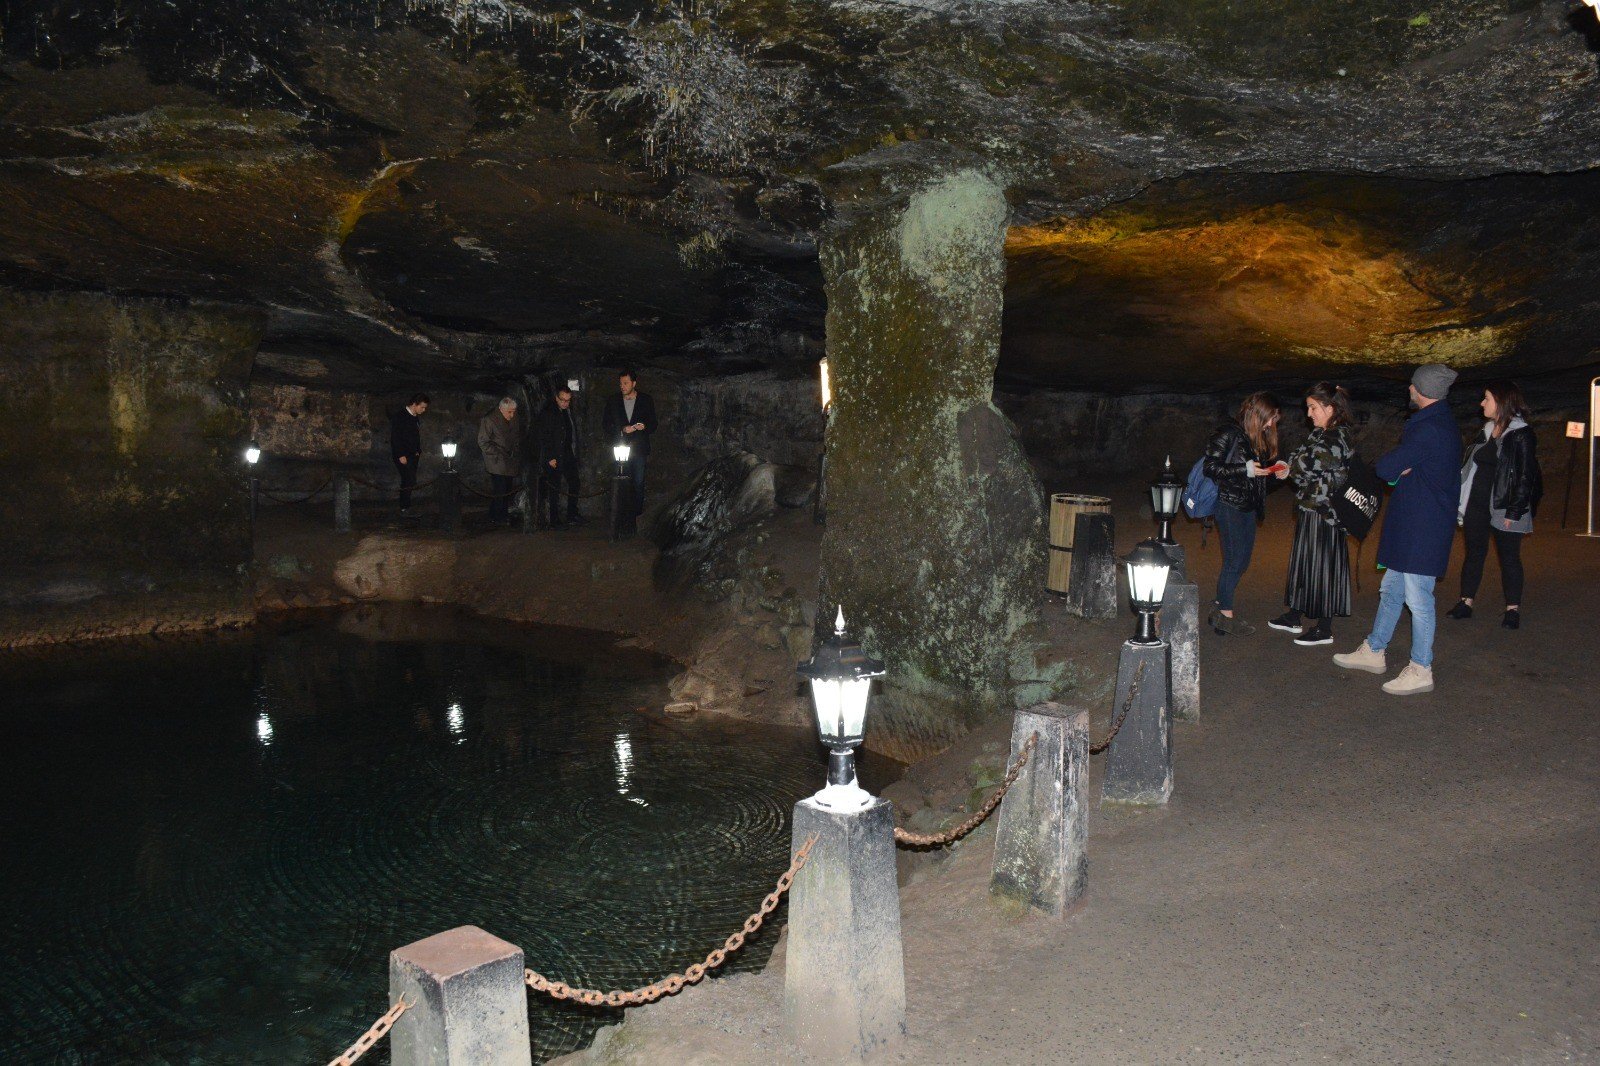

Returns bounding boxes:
[0,608,889,1063]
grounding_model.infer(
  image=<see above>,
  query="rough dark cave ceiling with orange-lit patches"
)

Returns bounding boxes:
[0,0,1600,391]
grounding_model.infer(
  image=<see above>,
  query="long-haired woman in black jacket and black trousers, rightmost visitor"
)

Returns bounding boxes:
[1446,381,1544,629]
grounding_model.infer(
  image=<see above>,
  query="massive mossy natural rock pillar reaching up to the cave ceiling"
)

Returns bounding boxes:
[818,141,1045,759]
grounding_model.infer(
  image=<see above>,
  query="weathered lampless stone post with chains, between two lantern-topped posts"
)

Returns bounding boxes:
[989,703,1090,917]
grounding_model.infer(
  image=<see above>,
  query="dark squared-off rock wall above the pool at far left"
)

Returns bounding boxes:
[0,290,264,643]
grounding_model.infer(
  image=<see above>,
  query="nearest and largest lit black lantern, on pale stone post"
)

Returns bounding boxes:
[795,607,883,810]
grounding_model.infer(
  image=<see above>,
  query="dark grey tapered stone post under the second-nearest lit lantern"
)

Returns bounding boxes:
[1101,640,1173,804]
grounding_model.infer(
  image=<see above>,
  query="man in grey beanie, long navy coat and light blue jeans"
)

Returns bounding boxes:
[1333,363,1461,696]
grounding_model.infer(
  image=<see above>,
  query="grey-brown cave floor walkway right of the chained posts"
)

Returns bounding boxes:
[574,485,1600,1064]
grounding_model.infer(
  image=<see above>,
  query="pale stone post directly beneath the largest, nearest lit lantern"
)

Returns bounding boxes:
[784,799,906,1063]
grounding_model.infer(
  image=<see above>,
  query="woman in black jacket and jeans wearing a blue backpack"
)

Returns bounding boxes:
[1203,392,1286,637]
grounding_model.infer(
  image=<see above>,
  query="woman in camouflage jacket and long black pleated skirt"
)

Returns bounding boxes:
[1267,381,1355,647]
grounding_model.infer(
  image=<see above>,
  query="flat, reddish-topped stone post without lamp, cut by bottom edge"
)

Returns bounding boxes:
[389,925,533,1066]
